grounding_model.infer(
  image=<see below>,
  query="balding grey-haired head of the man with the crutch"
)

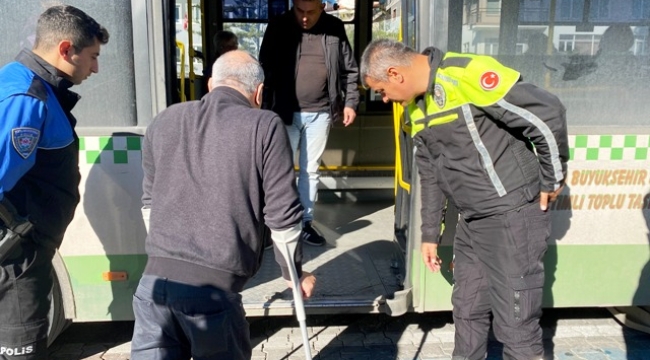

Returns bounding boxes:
[211,50,264,95]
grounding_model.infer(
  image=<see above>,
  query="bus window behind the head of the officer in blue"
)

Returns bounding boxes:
[0,0,137,127]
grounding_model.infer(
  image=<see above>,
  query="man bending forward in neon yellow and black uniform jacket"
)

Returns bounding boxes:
[361,40,569,360]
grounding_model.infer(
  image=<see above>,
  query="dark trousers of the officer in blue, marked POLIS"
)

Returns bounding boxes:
[0,241,54,360]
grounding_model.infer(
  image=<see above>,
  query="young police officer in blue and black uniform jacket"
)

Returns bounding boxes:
[0,6,108,360]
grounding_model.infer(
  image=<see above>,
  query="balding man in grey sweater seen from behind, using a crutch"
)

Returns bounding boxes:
[131,50,315,360]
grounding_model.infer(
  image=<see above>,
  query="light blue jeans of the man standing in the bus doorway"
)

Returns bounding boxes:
[286,112,332,223]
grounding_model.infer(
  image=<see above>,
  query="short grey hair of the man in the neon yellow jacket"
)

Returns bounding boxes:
[360,39,417,87]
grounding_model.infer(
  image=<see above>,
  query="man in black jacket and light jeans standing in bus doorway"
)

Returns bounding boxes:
[260,0,359,246]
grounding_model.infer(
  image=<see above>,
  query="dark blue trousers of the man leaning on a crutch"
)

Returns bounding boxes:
[131,275,252,360]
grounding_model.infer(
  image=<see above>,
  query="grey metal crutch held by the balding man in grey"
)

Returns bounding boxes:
[273,225,312,360]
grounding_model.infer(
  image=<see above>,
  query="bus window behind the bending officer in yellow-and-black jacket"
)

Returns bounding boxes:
[462,0,650,126]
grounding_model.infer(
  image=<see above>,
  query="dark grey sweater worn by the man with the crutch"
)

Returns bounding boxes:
[142,87,302,292]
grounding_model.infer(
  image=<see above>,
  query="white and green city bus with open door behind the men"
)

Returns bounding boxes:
[0,0,650,340]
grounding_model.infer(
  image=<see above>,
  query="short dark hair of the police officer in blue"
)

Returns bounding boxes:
[34,5,109,51]
